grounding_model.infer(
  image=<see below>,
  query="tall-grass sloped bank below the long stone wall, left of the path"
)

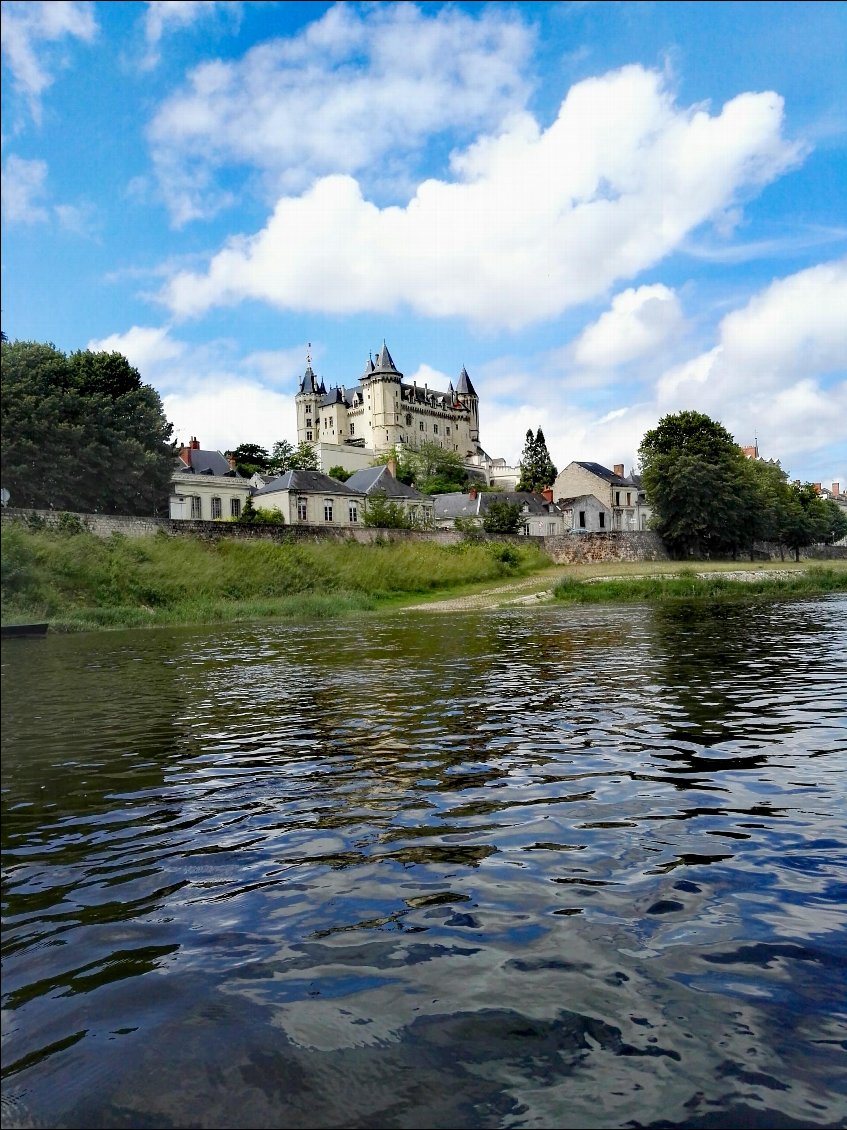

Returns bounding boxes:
[0,523,550,632]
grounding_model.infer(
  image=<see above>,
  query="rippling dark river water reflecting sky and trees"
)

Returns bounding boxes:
[2,597,847,1130]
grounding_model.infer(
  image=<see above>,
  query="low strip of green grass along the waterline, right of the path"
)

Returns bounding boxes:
[553,563,847,605]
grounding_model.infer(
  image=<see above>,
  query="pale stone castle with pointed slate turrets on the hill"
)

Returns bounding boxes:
[295,344,515,483]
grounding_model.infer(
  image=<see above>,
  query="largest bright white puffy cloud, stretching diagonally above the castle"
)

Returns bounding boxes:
[161,67,800,329]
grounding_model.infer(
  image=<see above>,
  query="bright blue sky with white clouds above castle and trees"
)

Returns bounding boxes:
[0,0,847,489]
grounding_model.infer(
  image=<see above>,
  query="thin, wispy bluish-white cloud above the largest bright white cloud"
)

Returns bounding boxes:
[148,3,531,225]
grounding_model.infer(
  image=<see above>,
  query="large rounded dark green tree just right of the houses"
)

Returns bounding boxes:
[639,411,751,557]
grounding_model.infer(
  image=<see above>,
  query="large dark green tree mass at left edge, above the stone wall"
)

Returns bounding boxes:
[0,341,174,514]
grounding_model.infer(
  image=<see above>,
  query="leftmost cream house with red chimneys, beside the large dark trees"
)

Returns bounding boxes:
[169,436,253,521]
